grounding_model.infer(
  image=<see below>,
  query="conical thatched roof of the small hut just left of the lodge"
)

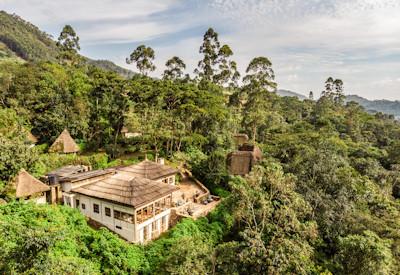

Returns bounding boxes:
[15,169,50,198]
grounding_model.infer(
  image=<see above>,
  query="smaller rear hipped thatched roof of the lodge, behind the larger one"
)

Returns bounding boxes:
[117,160,178,180]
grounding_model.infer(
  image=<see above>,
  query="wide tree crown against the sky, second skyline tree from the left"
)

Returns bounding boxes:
[126,45,156,75]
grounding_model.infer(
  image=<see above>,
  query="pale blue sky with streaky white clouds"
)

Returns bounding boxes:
[0,0,400,100]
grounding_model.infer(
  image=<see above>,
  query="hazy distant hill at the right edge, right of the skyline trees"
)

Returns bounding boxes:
[346,95,400,117]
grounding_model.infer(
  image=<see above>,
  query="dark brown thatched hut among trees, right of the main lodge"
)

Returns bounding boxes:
[227,144,262,176]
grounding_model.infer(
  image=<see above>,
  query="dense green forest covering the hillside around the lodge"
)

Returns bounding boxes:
[0,14,400,274]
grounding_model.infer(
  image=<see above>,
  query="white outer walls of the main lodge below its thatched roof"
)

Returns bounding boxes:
[64,193,171,243]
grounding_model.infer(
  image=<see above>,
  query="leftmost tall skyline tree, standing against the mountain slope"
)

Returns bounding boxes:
[57,25,81,65]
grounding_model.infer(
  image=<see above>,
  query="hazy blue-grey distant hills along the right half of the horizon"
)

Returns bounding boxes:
[276,89,400,117]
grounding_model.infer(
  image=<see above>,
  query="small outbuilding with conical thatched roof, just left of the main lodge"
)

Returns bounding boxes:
[15,169,50,203]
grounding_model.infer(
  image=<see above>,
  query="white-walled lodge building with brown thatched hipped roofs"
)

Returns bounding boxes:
[48,160,179,243]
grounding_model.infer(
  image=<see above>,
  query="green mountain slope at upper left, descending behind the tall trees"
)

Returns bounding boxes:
[0,11,134,77]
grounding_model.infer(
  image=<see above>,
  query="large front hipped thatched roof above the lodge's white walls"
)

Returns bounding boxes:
[73,173,179,208]
